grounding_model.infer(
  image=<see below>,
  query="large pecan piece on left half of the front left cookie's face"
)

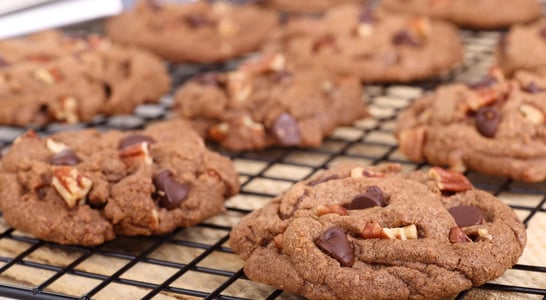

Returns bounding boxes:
[51,167,93,208]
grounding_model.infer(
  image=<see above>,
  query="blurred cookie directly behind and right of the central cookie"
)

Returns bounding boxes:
[264,4,462,82]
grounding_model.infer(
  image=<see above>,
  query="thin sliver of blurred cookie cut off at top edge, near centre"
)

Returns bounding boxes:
[260,0,364,13]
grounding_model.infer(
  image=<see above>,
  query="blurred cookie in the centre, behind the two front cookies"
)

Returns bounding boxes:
[173,54,367,151]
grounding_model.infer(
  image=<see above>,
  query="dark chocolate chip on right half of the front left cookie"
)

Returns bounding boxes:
[153,170,190,210]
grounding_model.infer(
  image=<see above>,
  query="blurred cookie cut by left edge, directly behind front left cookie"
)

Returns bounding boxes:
[0,31,170,126]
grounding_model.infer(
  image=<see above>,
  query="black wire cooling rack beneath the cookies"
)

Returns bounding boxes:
[0,26,546,299]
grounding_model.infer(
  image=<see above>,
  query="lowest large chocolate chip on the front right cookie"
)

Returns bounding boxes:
[315,227,355,267]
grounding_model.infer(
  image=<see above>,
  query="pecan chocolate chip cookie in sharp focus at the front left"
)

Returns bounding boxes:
[0,120,239,245]
